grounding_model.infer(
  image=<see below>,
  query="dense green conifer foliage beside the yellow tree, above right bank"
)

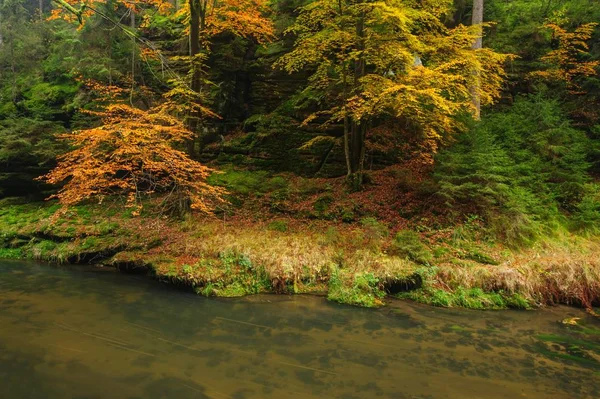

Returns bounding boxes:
[435,95,589,246]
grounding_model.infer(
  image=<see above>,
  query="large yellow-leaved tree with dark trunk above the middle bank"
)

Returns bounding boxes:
[277,0,509,188]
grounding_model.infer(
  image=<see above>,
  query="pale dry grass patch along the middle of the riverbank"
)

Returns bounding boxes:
[152,219,414,288]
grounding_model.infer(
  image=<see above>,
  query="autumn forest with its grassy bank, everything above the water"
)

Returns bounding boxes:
[0,0,600,313]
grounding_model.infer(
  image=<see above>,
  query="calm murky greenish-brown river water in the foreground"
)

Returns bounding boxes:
[0,261,600,399]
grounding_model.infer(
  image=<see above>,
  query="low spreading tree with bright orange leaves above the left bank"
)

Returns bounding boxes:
[40,104,224,214]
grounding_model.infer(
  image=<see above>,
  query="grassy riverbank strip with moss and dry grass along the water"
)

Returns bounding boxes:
[0,200,600,309]
